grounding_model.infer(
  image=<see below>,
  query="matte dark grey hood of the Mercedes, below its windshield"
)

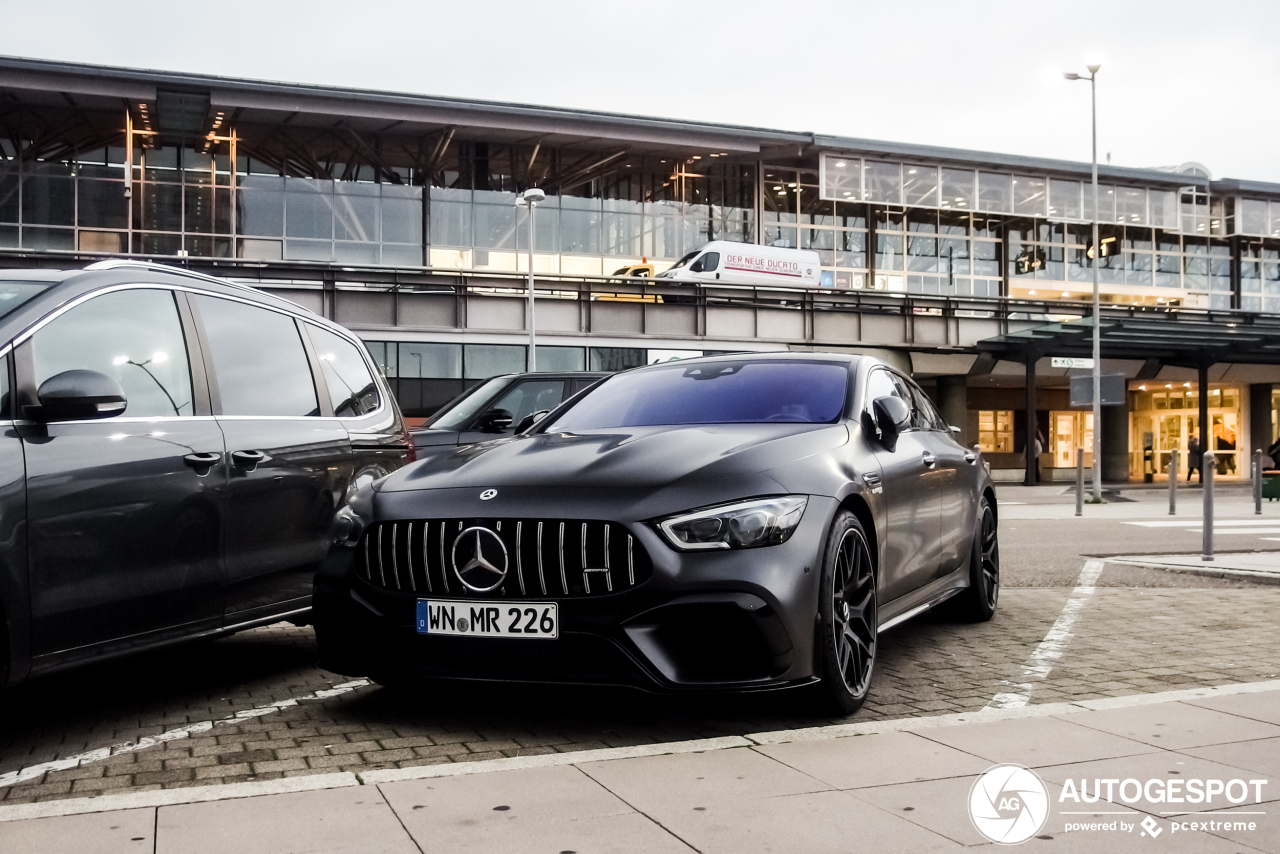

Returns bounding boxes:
[378,424,849,492]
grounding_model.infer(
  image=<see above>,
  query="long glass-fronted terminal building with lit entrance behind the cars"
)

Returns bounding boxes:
[0,59,1280,480]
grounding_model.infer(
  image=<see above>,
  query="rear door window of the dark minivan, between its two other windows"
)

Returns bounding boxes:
[196,296,320,416]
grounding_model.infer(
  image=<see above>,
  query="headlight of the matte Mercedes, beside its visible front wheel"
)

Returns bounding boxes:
[658,495,809,552]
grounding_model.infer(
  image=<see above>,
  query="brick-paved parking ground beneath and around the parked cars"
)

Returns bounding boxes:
[0,487,1280,804]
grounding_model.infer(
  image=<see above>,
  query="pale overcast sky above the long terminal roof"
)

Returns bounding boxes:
[0,0,1280,182]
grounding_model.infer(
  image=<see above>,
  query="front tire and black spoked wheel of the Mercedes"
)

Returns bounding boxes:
[817,511,878,714]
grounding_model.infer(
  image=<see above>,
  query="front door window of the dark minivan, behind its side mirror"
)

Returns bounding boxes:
[30,289,193,417]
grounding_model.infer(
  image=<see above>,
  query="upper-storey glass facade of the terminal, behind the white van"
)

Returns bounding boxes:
[0,96,1280,317]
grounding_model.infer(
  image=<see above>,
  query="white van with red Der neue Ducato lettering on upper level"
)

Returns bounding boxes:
[657,241,822,288]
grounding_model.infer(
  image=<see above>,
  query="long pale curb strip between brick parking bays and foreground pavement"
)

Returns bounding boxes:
[0,680,1280,822]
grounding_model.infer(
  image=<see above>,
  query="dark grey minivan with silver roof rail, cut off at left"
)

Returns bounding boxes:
[0,261,411,685]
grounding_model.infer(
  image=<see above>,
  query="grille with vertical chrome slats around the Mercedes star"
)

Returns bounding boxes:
[356,519,653,598]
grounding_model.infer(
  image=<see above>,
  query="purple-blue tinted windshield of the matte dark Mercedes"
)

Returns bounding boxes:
[547,360,849,433]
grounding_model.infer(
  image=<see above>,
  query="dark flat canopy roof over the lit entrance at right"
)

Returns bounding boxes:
[978,311,1280,367]
